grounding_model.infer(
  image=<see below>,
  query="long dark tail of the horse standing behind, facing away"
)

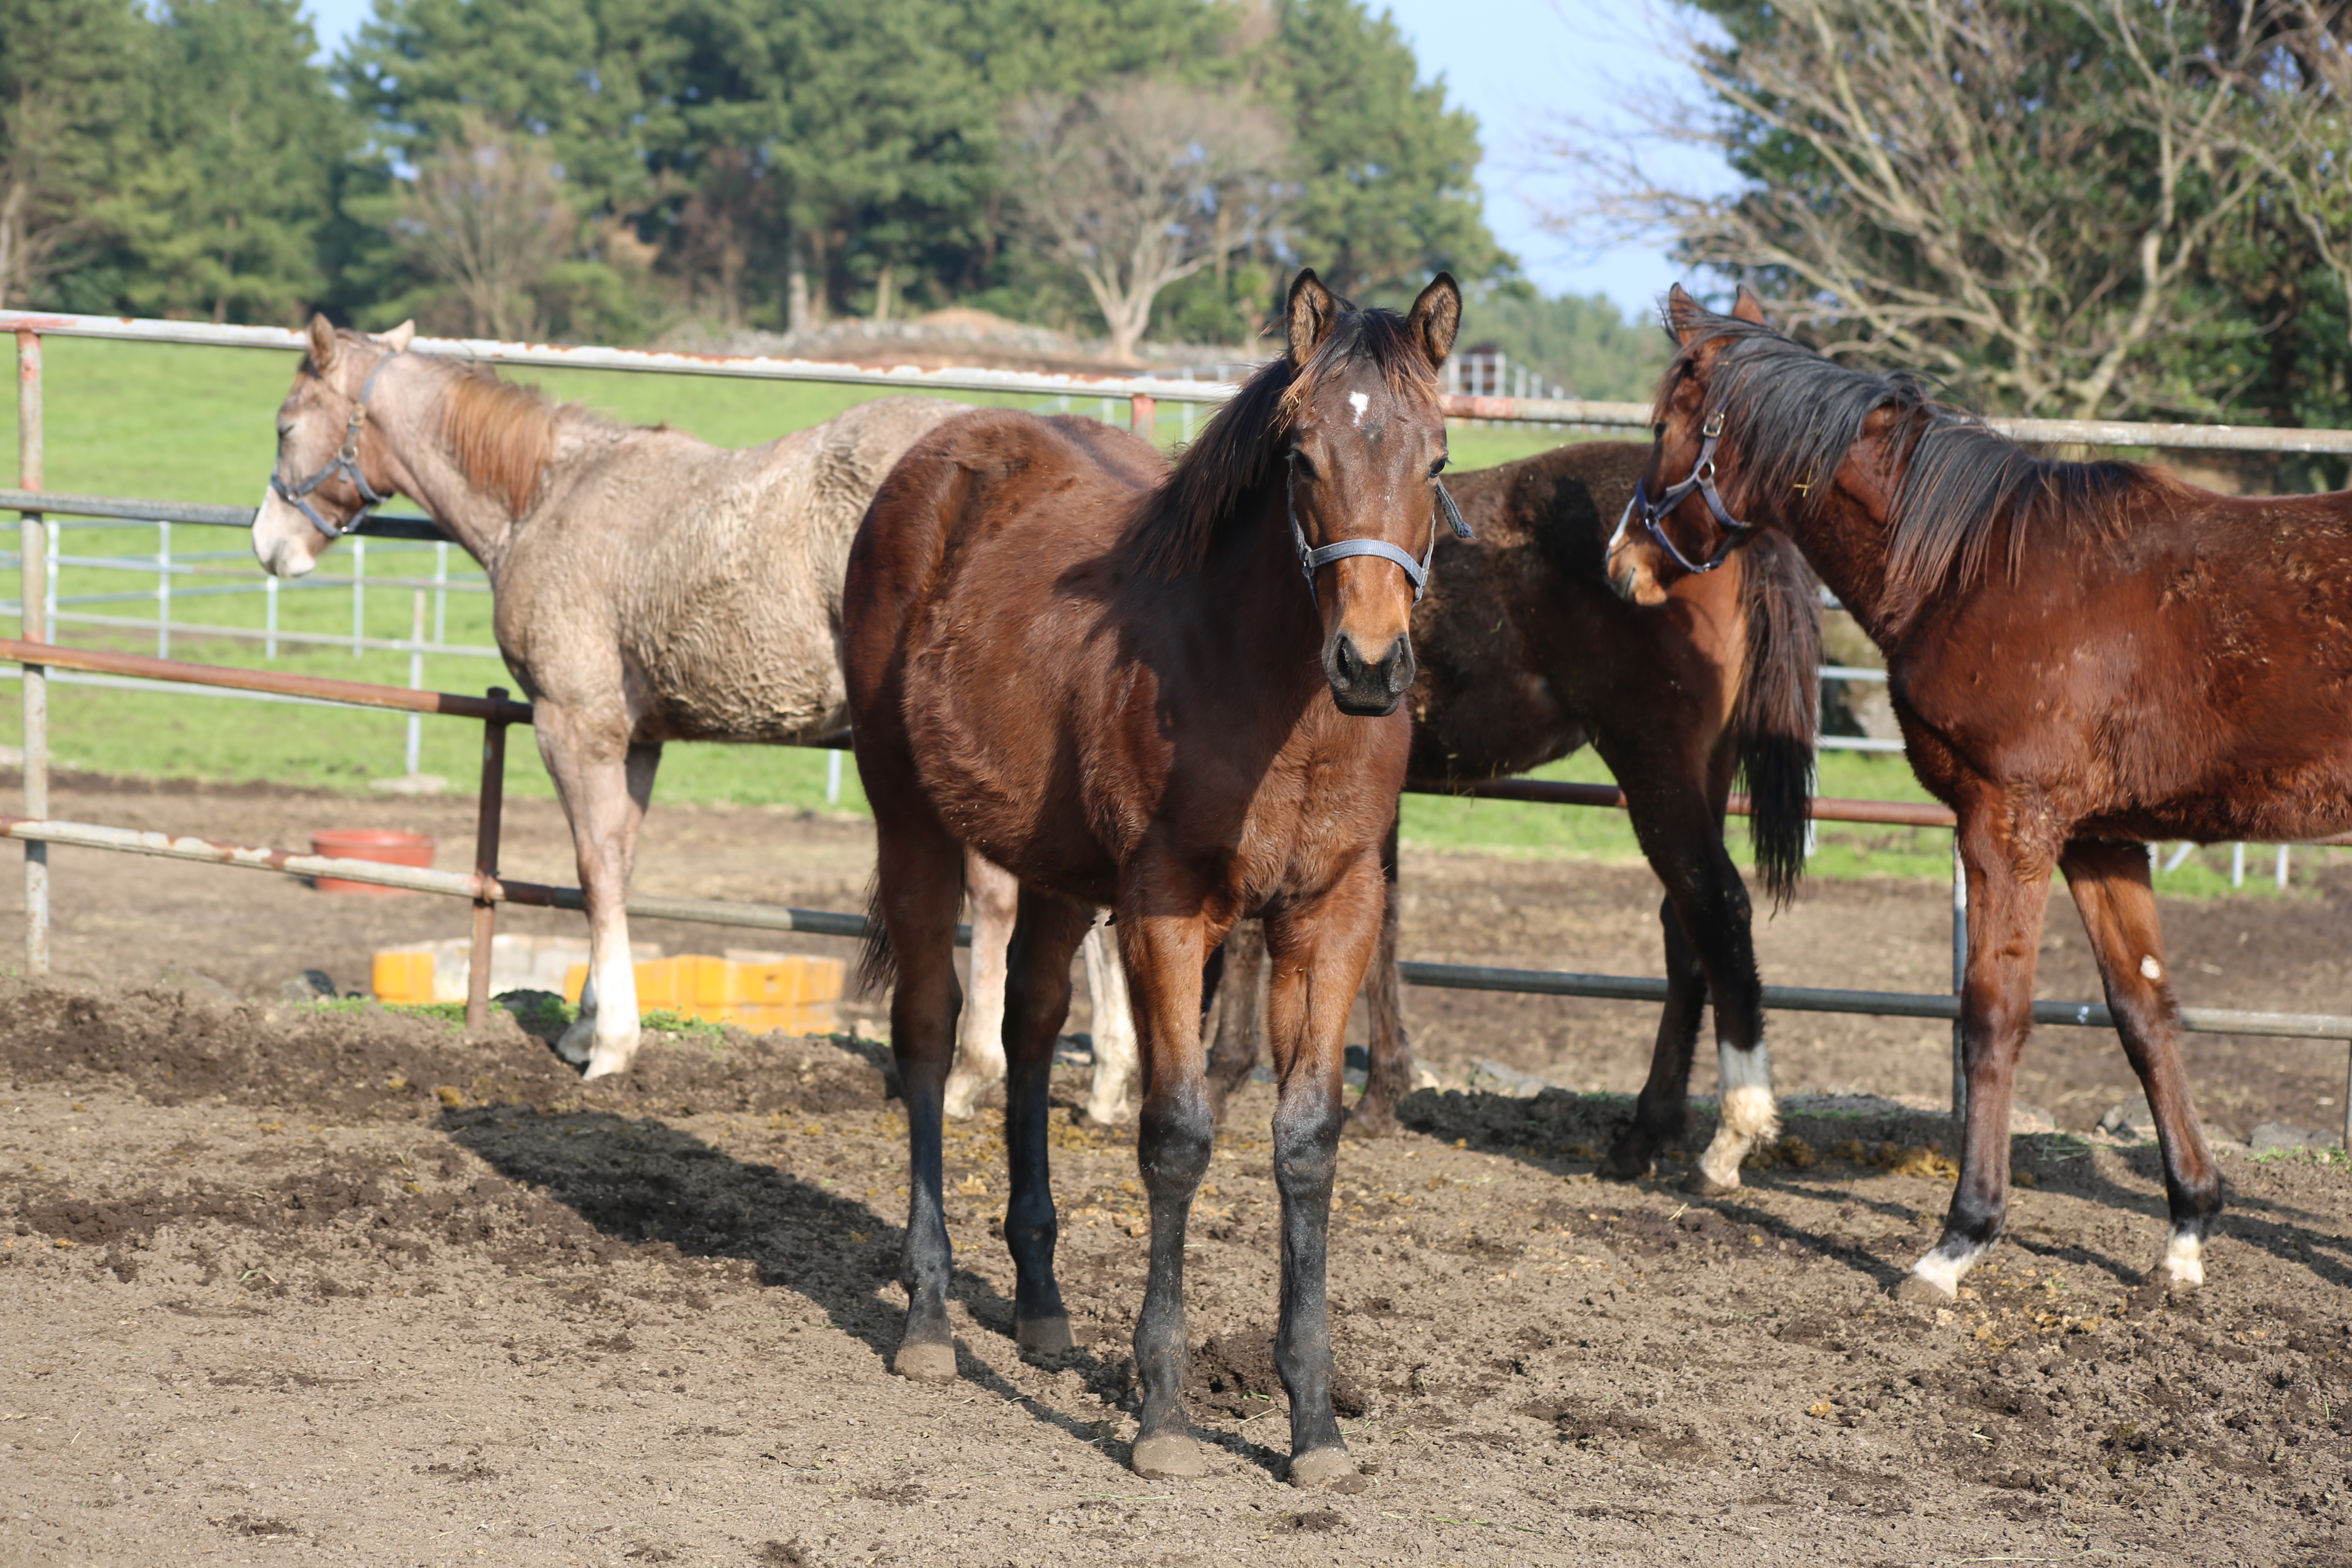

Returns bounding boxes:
[1731,534,1820,907]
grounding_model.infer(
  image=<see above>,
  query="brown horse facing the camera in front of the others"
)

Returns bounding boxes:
[842,273,1461,1486]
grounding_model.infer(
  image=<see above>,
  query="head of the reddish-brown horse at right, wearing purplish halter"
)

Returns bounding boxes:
[1609,282,1769,604]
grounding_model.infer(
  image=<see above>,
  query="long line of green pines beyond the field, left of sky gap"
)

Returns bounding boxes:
[0,0,1524,353]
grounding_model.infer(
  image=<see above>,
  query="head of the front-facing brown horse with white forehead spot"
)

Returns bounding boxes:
[1282,270,1465,717]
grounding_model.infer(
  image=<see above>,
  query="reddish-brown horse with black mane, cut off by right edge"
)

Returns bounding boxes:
[1611,289,2352,1300]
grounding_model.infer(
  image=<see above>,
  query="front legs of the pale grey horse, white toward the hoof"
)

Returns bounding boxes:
[534,701,661,1079]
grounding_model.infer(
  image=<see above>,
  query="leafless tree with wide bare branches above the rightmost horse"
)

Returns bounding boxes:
[1548,0,2276,416]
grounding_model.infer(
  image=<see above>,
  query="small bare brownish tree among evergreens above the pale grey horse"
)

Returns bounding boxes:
[397,120,579,339]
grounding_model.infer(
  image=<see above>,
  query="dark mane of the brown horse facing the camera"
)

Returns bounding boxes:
[1127,301,1437,581]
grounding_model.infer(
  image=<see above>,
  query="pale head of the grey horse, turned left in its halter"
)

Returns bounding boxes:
[254,315,416,576]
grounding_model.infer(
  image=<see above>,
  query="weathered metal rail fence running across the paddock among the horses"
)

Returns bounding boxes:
[0,310,2352,1145]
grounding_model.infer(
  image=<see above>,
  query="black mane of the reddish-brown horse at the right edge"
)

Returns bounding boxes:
[1651,305,2147,599]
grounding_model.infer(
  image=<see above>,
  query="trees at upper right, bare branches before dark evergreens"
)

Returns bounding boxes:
[1555,0,2352,482]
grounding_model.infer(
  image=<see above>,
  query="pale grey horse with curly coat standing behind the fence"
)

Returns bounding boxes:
[252,317,1131,1081]
